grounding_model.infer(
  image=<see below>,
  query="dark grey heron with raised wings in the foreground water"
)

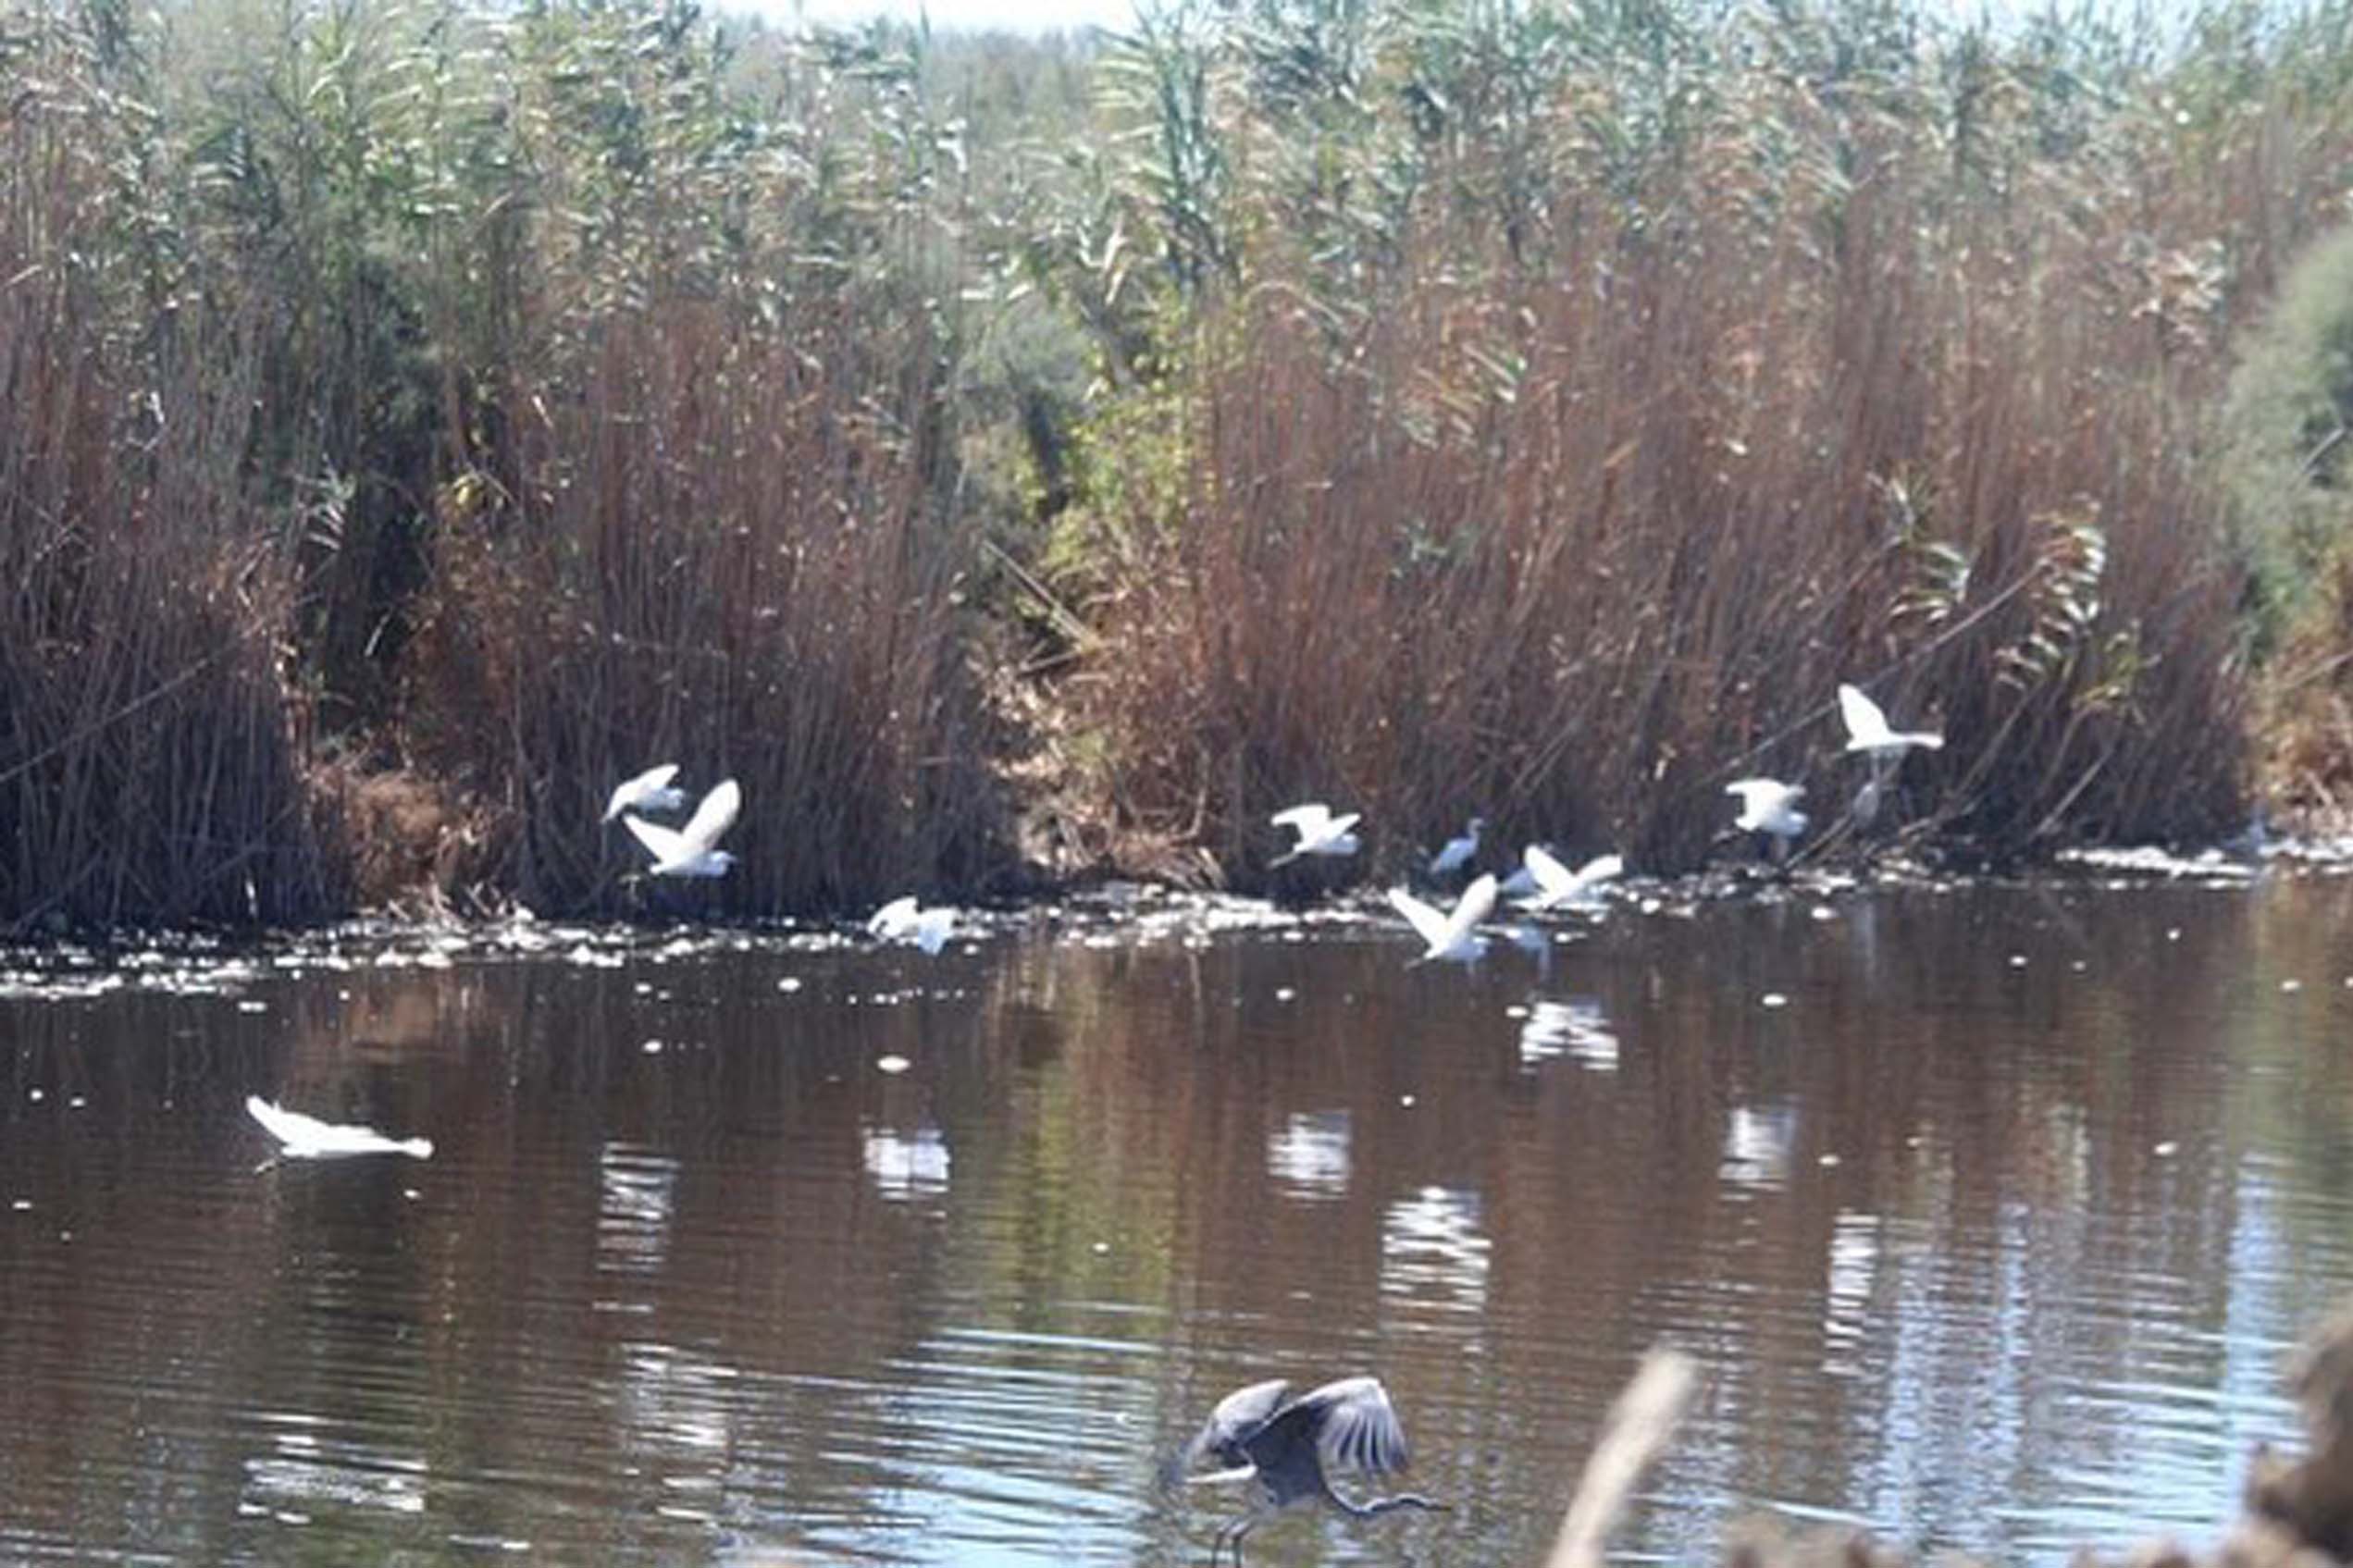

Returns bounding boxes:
[1170,1377,1447,1568]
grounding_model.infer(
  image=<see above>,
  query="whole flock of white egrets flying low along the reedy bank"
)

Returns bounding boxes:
[244,686,1944,1159]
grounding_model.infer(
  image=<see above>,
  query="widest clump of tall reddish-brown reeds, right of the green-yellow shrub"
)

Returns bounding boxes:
[1073,45,2306,874]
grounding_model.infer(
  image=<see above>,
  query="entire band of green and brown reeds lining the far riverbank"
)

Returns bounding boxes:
[0,0,2353,924]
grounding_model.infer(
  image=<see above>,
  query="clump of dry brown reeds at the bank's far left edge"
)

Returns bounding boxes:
[0,52,341,931]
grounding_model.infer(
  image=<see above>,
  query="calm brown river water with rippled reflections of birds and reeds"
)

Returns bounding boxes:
[0,882,2353,1565]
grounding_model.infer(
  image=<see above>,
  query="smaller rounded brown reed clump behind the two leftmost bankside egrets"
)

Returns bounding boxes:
[412,301,997,912]
